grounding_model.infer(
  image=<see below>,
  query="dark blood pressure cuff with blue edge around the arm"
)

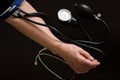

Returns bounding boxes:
[0,0,24,20]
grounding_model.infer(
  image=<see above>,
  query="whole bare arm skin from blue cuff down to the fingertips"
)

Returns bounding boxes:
[5,1,100,73]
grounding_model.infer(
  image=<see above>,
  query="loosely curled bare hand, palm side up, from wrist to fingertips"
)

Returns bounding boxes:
[50,43,100,73]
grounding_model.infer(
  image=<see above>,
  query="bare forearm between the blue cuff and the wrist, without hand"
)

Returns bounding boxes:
[6,1,60,49]
